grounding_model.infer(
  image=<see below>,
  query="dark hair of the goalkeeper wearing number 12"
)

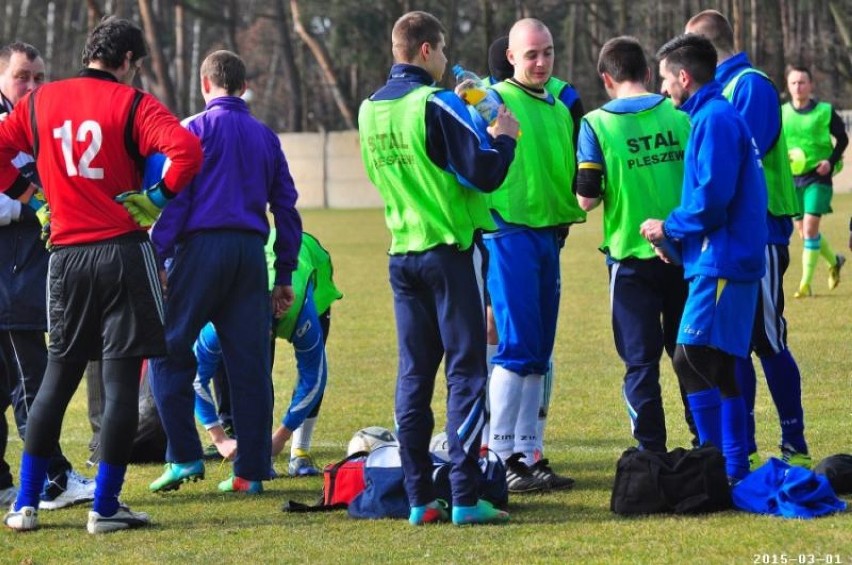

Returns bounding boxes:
[83,16,148,69]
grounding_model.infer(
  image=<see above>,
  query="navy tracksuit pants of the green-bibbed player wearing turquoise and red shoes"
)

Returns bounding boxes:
[389,245,487,506]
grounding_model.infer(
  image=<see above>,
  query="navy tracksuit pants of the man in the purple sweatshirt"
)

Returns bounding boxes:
[151,230,272,481]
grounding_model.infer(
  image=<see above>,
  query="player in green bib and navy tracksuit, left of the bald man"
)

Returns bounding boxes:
[358,12,518,525]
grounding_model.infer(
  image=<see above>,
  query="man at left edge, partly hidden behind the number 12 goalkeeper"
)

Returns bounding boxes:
[0,43,95,510]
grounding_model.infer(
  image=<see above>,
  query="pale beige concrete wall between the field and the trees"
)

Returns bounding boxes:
[278,115,852,208]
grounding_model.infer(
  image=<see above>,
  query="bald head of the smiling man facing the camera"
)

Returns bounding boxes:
[506,18,553,88]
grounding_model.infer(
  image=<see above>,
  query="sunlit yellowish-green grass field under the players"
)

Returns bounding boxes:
[0,195,852,564]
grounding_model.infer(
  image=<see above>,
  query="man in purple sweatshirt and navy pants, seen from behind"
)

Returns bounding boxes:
[149,51,302,493]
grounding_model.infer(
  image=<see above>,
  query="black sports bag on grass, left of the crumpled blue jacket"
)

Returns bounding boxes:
[610,444,732,516]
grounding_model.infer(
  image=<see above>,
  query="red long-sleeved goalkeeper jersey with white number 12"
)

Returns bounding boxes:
[0,69,202,245]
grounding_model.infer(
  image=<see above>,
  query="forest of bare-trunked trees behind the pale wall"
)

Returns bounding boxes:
[0,0,852,133]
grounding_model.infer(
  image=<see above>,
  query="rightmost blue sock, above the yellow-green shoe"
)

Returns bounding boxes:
[760,349,808,453]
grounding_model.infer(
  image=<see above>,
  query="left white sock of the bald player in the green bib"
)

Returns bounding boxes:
[488,365,524,460]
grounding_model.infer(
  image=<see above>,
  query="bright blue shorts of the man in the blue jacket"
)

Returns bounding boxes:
[677,275,760,357]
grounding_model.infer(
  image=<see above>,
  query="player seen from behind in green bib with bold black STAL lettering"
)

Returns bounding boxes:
[577,37,689,452]
